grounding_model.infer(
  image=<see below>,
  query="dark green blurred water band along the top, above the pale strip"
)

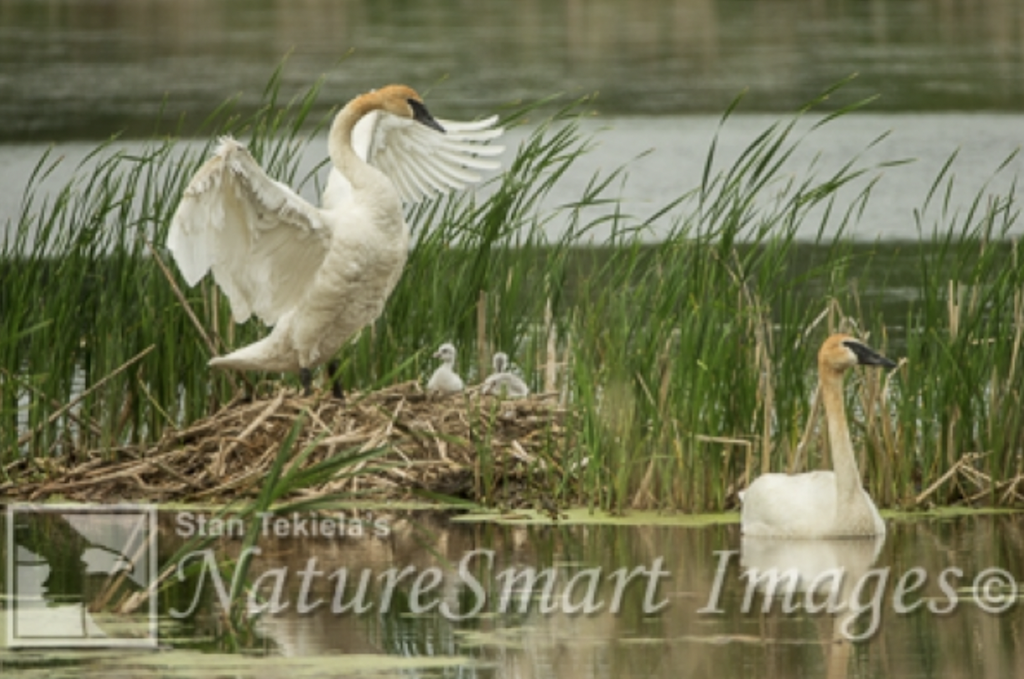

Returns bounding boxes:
[0,0,1024,141]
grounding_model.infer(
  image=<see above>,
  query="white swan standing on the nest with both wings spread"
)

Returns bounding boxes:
[167,85,502,397]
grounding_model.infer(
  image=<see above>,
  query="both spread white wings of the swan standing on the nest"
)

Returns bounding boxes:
[174,111,504,325]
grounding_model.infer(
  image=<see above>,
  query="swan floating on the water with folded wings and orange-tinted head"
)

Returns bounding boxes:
[739,335,896,538]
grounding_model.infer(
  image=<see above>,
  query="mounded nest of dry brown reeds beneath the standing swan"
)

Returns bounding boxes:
[0,382,566,506]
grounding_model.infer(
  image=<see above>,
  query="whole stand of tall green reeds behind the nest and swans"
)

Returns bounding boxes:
[0,76,1024,512]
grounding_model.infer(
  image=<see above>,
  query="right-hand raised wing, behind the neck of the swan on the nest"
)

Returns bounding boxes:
[324,111,505,209]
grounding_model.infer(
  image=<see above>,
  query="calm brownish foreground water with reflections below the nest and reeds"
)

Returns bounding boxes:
[0,513,1024,677]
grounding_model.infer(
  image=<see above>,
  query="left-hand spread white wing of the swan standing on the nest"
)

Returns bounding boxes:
[167,137,331,325]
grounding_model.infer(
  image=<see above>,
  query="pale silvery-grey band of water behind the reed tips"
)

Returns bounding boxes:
[0,113,1024,244]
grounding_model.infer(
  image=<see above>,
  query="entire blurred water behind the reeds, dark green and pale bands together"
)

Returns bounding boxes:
[0,0,1024,240]
